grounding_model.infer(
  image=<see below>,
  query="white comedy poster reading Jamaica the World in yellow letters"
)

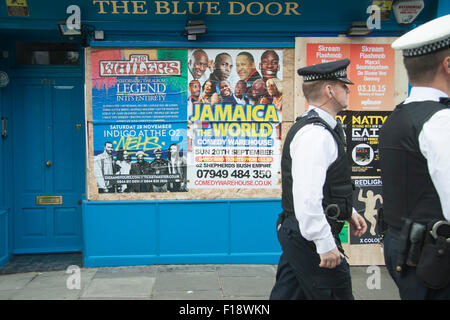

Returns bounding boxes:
[188,49,283,188]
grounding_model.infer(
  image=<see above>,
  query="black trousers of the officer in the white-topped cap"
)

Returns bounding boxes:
[384,232,450,300]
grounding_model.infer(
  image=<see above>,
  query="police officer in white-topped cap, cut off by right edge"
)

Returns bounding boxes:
[379,15,450,299]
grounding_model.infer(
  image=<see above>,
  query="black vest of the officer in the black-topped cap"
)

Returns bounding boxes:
[281,110,353,238]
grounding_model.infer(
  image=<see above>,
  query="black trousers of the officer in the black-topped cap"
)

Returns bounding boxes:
[270,218,354,300]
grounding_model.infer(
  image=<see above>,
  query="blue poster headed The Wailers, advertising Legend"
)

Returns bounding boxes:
[91,49,187,193]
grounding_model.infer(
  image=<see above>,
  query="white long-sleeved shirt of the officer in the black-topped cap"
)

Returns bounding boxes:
[290,106,338,254]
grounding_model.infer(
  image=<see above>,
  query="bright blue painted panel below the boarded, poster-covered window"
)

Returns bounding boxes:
[83,199,281,267]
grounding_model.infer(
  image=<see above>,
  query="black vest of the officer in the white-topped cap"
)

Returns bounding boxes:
[379,101,448,229]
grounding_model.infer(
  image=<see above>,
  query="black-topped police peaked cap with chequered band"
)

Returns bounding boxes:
[297,59,353,84]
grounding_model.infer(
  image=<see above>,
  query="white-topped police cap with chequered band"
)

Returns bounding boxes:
[392,14,450,57]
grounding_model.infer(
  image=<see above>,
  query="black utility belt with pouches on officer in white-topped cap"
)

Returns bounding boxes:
[379,212,450,289]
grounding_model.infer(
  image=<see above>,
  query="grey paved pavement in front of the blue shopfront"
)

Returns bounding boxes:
[0,258,399,300]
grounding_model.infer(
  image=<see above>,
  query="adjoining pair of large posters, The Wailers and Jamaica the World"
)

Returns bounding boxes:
[91,49,283,193]
